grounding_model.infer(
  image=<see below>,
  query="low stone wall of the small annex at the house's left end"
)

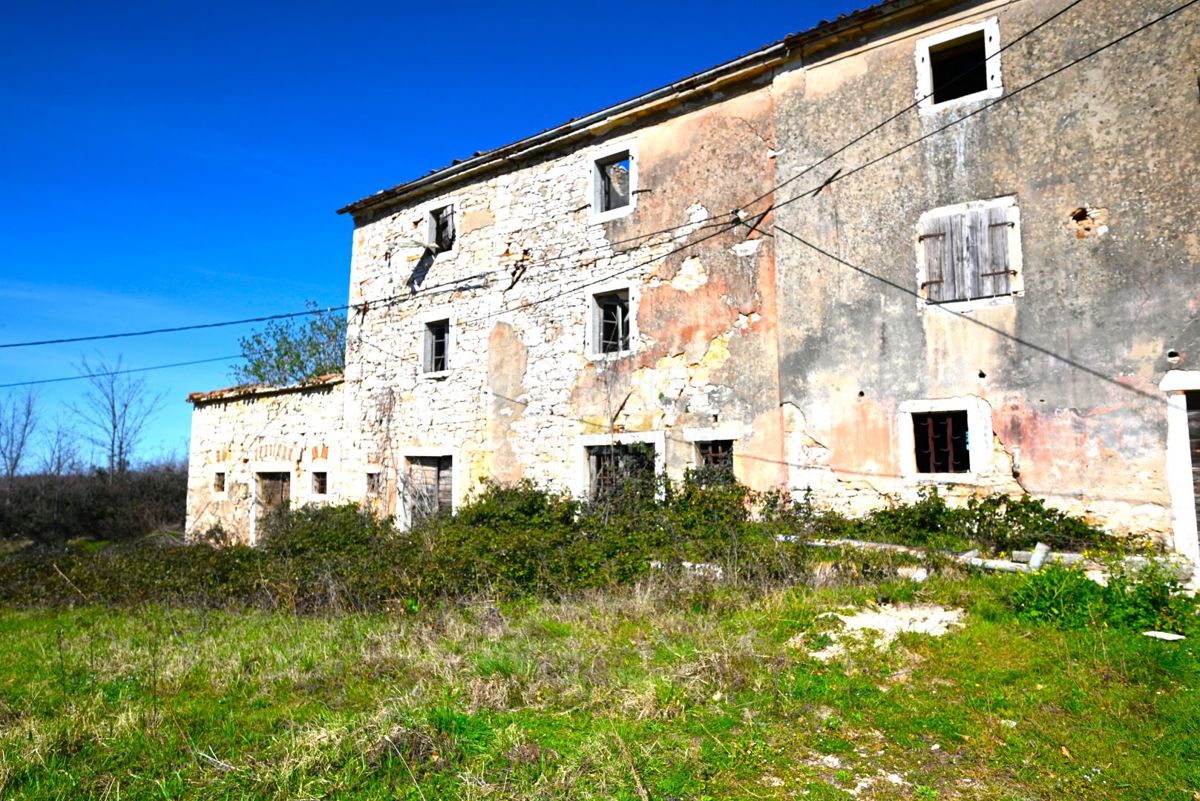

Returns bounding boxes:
[186,383,343,542]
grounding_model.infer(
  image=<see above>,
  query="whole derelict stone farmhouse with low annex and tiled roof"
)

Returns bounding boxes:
[188,0,1200,559]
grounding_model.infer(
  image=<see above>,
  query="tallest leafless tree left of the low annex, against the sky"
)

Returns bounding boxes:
[71,356,163,481]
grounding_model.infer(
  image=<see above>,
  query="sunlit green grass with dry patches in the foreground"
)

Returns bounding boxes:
[0,578,1200,801]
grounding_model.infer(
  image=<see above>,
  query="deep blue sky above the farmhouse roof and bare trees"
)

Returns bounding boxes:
[0,0,866,458]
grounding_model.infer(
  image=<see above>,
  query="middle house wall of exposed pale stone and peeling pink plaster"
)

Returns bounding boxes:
[347,89,784,520]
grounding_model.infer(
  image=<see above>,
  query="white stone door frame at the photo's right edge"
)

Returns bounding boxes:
[1158,369,1200,568]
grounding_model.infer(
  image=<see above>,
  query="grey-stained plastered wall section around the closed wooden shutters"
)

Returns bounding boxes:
[774,0,1200,544]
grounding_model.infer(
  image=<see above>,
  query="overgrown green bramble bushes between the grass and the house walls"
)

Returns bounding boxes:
[0,472,1137,625]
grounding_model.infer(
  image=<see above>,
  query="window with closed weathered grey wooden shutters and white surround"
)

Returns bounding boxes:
[919,203,1018,303]
